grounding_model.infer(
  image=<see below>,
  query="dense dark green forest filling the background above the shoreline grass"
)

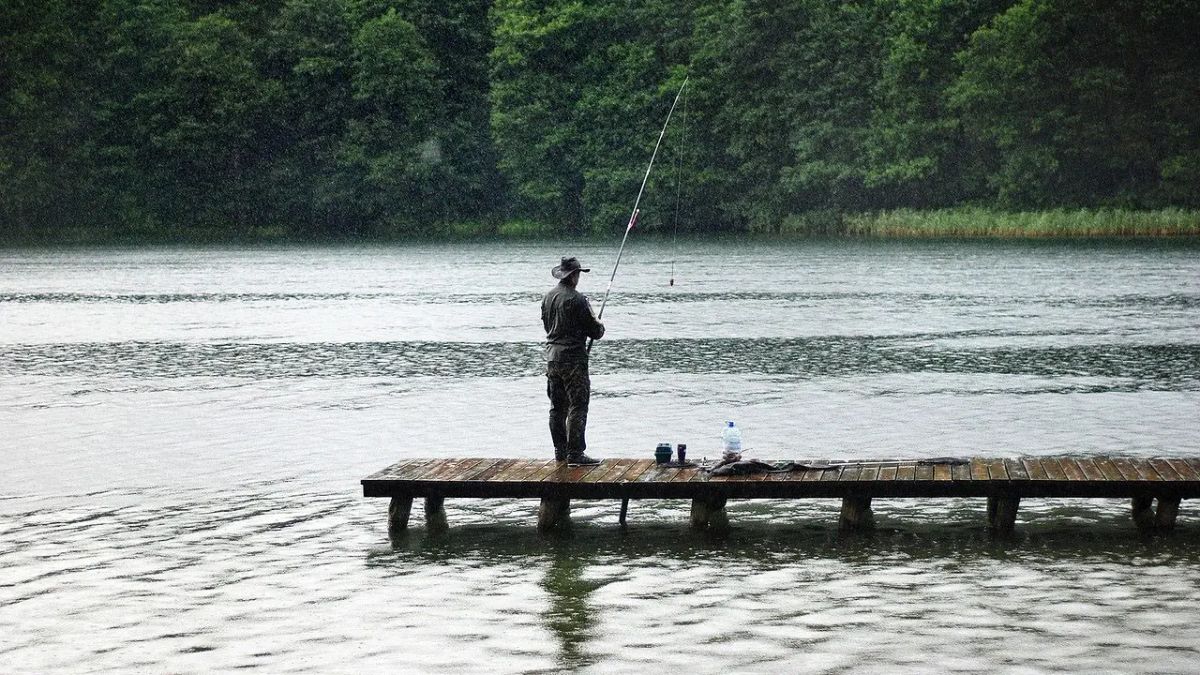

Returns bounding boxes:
[0,0,1200,238]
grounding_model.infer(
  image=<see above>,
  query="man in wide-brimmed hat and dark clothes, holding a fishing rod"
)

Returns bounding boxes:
[541,258,604,466]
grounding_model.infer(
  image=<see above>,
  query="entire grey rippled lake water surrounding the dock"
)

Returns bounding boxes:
[0,237,1200,673]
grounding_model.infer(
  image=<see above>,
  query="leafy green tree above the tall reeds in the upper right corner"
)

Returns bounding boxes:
[949,0,1200,207]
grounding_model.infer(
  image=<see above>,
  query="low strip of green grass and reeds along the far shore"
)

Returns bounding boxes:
[0,208,1200,249]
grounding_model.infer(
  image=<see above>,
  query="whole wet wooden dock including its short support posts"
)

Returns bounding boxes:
[362,456,1200,533]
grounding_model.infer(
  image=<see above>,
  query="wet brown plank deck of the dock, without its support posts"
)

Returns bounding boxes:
[362,456,1200,498]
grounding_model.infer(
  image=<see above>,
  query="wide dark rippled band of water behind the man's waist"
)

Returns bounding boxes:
[0,336,1200,392]
